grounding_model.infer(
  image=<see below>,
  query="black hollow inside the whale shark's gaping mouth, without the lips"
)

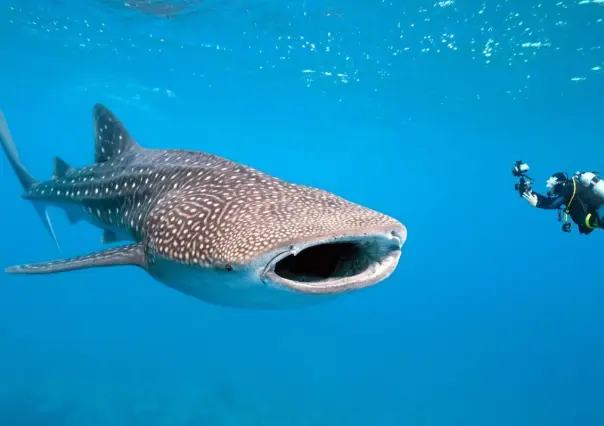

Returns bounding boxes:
[275,241,379,283]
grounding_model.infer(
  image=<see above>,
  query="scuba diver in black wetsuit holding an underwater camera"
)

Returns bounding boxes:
[512,161,604,235]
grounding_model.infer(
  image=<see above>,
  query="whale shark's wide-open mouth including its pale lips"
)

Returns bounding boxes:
[263,232,404,294]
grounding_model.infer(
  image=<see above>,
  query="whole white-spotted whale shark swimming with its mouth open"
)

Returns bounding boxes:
[0,104,406,308]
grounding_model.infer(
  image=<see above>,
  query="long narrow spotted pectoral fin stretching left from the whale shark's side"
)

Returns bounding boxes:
[6,243,147,274]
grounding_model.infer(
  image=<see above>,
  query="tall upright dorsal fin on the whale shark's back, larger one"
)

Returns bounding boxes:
[93,104,139,163]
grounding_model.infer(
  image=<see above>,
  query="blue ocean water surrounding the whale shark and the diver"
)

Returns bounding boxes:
[0,0,604,426]
